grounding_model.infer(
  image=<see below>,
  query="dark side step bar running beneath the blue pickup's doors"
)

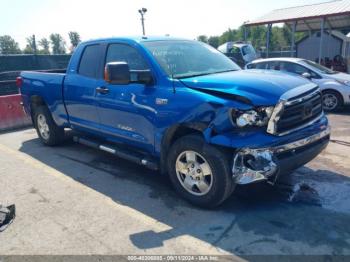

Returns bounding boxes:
[73,136,159,170]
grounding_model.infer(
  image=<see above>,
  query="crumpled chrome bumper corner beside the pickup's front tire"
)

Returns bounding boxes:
[232,149,278,185]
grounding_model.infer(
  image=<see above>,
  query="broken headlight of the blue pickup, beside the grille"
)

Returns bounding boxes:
[231,106,274,127]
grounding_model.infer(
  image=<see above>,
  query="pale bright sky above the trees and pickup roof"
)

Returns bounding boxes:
[0,0,327,48]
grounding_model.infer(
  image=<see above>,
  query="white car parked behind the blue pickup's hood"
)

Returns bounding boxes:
[245,57,350,111]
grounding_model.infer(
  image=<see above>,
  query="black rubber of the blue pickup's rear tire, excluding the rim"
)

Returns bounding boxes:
[33,106,64,146]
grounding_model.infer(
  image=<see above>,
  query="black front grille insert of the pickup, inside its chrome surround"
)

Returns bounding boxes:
[276,92,322,133]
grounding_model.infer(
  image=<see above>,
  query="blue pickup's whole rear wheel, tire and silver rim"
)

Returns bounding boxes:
[34,106,64,146]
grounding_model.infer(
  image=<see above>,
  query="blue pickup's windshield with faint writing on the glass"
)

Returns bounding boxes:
[142,41,240,78]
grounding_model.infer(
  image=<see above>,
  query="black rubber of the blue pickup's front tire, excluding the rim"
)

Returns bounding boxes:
[167,135,235,208]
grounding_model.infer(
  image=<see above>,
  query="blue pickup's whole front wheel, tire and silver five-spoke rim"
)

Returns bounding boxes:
[168,135,235,208]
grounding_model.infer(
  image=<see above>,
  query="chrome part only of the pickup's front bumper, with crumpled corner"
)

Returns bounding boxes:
[232,127,330,184]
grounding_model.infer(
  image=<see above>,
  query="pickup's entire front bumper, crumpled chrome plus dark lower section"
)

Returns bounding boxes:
[232,121,330,184]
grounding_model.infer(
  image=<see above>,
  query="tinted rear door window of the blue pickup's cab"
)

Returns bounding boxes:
[78,45,102,78]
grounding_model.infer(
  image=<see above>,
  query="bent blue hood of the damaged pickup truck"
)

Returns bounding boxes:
[181,70,316,106]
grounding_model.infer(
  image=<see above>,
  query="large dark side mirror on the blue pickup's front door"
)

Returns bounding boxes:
[104,62,130,85]
